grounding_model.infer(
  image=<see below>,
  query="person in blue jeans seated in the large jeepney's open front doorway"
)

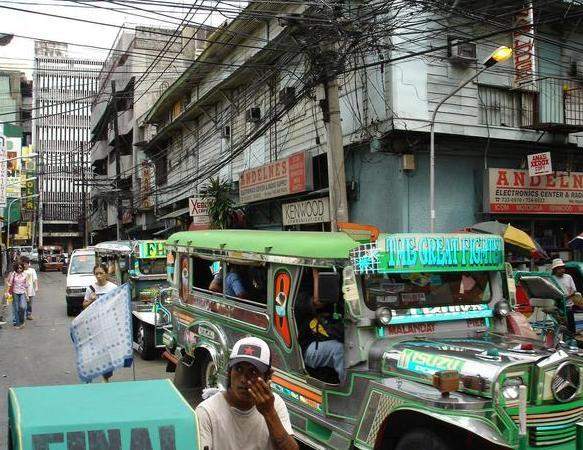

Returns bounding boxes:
[294,268,346,384]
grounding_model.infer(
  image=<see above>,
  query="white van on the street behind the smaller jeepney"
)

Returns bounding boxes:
[66,248,96,316]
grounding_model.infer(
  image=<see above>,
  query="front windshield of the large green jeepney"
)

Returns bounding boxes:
[362,272,492,309]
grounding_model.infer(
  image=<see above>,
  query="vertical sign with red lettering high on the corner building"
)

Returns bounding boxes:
[513,3,535,89]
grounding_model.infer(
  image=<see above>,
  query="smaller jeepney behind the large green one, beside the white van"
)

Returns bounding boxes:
[95,240,170,360]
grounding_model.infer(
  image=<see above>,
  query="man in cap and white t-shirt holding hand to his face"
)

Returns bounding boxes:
[196,337,299,450]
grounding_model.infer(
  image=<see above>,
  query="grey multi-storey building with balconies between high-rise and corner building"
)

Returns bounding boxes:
[90,25,209,242]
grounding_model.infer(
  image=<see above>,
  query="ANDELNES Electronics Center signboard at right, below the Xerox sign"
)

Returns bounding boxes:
[484,169,583,214]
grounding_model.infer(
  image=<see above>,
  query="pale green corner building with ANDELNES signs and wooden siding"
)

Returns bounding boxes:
[144,1,583,264]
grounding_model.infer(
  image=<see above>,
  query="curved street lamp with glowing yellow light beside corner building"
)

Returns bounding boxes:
[429,46,512,233]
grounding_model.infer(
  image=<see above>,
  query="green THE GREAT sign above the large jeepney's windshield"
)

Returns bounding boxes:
[352,233,504,273]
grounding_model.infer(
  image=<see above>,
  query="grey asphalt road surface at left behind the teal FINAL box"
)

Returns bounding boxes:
[0,272,174,449]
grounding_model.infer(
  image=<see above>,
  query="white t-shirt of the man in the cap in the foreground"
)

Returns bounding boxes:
[196,392,293,450]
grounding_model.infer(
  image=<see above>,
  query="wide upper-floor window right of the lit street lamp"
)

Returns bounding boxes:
[478,86,534,128]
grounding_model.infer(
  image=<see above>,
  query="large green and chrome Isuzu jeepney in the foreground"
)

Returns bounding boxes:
[164,230,583,450]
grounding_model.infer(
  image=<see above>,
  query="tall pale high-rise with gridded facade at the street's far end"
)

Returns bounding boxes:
[33,41,102,249]
